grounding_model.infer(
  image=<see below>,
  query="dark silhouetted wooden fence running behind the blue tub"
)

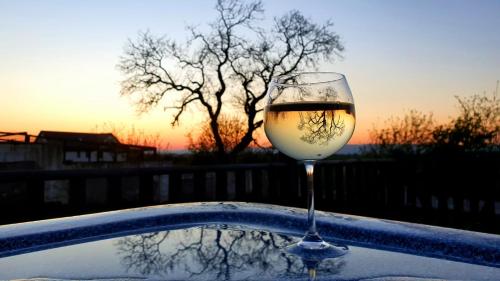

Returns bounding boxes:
[0,159,500,233]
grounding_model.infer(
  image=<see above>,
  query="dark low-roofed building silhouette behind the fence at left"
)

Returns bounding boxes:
[0,131,156,169]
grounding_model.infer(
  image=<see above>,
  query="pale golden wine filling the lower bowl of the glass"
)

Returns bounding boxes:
[264,102,356,160]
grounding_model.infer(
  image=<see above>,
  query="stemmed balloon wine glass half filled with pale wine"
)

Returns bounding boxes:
[264,72,356,260]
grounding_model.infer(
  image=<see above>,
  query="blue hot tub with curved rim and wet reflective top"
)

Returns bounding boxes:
[0,202,500,281]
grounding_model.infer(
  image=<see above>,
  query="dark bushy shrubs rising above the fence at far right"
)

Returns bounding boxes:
[371,94,500,155]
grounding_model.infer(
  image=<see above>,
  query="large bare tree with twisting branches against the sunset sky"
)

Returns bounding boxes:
[118,0,344,156]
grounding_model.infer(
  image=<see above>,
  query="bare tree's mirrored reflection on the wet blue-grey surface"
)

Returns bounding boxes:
[115,226,344,280]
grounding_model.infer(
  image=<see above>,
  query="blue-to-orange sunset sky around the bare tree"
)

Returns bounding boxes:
[0,0,500,149]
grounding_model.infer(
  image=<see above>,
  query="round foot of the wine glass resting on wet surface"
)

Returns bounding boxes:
[286,236,349,261]
